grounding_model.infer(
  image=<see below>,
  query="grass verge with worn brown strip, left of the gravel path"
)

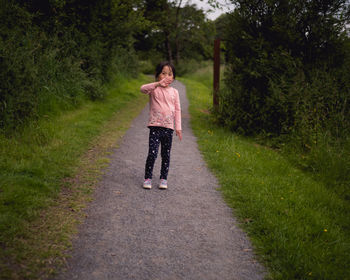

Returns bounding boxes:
[0,76,149,279]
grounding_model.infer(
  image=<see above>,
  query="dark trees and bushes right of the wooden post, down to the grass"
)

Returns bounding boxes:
[219,0,350,199]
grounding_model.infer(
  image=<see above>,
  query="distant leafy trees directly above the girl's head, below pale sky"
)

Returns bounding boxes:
[136,0,215,67]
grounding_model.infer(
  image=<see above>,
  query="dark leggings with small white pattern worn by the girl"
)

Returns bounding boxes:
[145,126,174,180]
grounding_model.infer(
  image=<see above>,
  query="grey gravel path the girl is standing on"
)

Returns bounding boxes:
[56,81,264,280]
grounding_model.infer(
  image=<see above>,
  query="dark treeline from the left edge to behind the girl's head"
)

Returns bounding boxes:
[0,0,214,131]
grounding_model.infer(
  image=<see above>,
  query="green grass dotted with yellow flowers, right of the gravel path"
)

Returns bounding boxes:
[181,73,350,279]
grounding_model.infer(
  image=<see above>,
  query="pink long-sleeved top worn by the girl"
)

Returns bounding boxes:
[141,83,181,130]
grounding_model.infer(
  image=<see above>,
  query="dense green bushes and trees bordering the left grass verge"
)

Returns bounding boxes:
[0,0,144,130]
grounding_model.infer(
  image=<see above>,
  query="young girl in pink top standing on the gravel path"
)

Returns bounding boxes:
[141,61,182,189]
